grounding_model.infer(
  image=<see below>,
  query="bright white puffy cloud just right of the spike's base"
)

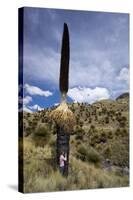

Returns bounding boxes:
[68,87,110,103]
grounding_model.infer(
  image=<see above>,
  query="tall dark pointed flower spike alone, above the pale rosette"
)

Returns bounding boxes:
[59,23,70,95]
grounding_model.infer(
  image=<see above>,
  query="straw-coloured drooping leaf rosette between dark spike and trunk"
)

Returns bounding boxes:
[50,102,76,134]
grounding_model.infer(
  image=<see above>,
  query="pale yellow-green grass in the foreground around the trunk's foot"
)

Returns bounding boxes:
[24,139,129,193]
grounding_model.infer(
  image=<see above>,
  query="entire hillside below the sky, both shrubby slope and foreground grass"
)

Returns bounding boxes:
[20,95,129,192]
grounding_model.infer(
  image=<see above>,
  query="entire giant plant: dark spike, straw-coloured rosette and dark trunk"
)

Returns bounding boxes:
[50,23,76,176]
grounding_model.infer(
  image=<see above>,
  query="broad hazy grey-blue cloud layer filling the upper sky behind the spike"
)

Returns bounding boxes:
[24,10,129,100]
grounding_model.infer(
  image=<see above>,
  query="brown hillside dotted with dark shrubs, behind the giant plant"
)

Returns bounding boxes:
[21,93,129,166]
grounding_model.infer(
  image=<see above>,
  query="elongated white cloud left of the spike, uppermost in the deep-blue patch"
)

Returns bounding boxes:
[24,84,52,97]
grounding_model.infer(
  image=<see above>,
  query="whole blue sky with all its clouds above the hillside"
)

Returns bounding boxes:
[20,8,129,112]
